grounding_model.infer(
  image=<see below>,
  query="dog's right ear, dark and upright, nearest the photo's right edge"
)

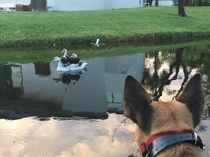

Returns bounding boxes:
[177,74,204,127]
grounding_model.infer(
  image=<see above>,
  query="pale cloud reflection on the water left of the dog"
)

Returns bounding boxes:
[0,114,137,157]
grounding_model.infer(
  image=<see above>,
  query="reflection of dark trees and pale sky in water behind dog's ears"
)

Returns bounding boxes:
[141,47,210,119]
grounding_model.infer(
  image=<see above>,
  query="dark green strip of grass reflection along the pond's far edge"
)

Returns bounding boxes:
[0,41,210,64]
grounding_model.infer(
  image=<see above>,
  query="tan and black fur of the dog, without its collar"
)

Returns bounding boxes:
[124,74,204,157]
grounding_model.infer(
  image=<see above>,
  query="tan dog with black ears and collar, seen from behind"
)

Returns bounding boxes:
[124,74,205,157]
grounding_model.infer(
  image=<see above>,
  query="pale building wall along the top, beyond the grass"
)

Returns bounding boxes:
[0,0,148,11]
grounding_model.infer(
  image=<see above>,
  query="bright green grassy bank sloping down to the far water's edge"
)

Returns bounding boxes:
[0,7,210,47]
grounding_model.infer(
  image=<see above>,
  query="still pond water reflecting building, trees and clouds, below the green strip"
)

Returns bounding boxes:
[0,42,210,157]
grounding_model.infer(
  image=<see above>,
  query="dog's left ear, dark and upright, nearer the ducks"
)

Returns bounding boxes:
[124,76,152,131]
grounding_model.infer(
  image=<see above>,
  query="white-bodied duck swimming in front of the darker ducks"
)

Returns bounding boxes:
[52,56,88,72]
